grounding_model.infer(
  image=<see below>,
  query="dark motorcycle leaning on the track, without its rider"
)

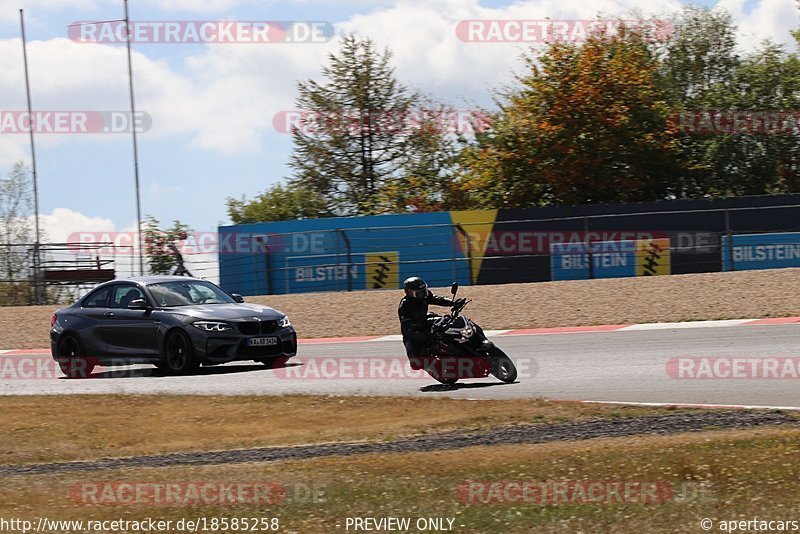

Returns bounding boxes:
[423,283,517,385]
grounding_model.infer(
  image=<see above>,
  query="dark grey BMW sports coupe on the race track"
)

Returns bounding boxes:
[50,276,297,378]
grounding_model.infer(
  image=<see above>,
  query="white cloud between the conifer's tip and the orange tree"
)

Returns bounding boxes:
[337,0,681,105]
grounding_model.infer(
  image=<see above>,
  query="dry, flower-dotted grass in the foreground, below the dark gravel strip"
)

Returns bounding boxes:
[0,428,800,532]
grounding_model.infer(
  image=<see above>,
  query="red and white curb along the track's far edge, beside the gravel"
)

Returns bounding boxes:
[6,317,800,355]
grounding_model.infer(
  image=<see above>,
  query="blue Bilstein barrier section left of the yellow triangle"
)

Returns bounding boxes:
[219,212,471,295]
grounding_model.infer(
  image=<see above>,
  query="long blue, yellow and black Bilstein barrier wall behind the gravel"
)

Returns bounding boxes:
[219,195,800,295]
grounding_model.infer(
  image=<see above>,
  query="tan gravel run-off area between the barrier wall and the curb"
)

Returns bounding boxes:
[0,269,800,349]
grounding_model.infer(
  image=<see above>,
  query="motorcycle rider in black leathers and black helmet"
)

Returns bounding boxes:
[397,276,463,371]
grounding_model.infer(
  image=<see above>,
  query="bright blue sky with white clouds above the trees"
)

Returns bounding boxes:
[0,0,800,280]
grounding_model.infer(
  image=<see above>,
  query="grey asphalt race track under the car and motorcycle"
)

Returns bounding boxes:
[0,324,800,409]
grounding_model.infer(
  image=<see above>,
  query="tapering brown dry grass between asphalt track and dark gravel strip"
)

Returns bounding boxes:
[0,395,664,464]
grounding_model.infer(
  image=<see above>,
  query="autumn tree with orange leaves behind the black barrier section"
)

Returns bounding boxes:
[460,27,681,207]
